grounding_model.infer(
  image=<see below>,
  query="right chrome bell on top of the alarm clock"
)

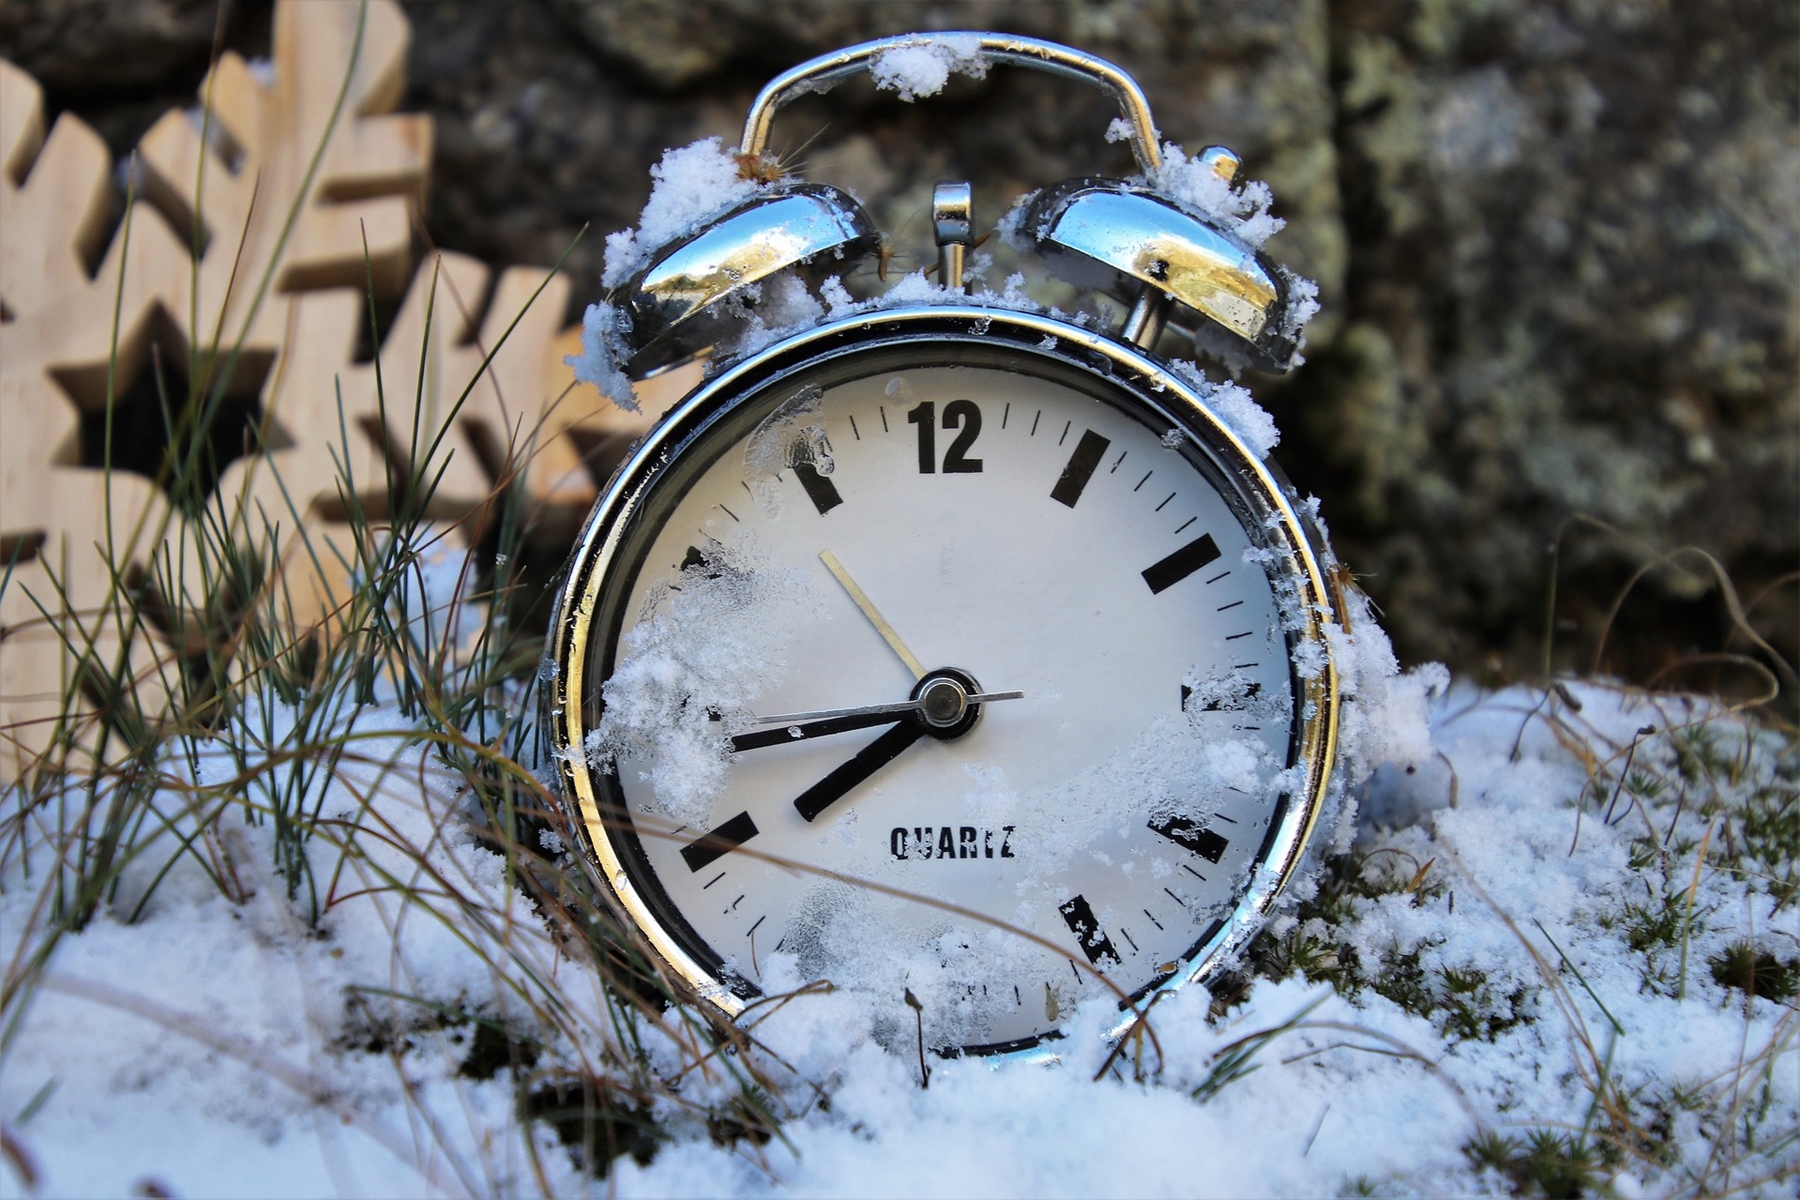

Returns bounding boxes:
[1019,165,1298,371]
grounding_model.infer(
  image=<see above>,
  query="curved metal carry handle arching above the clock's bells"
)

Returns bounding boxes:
[740,32,1163,175]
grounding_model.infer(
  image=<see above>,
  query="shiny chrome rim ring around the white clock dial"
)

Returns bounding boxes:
[544,304,1339,1052]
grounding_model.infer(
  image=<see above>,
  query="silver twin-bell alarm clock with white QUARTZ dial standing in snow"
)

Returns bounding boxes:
[544,34,1341,1054]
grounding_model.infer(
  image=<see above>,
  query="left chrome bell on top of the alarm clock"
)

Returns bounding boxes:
[614,184,878,380]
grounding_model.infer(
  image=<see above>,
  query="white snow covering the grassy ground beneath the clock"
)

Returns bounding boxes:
[0,684,1800,1196]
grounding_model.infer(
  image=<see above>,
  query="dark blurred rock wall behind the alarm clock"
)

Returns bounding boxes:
[0,0,1800,691]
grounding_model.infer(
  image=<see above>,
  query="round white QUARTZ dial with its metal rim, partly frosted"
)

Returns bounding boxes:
[547,315,1330,1047]
